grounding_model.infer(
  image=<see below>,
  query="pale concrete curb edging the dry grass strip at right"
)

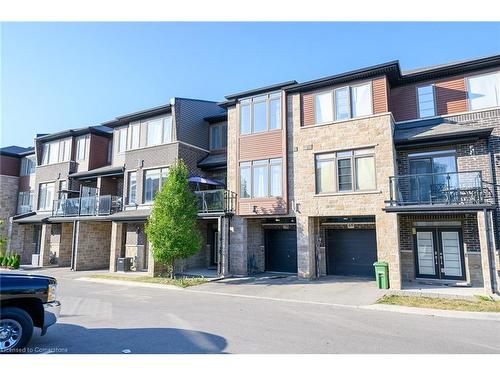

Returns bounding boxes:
[359,304,500,322]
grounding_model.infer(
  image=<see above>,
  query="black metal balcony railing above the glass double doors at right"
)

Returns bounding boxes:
[387,171,492,206]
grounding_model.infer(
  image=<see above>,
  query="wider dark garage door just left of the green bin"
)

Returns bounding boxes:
[327,229,377,277]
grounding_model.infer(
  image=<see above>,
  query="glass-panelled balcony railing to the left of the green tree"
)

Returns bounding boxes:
[52,195,122,216]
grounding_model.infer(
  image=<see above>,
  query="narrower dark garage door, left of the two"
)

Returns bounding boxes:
[266,229,297,273]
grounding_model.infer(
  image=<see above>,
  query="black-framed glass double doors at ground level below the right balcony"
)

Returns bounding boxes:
[415,228,465,280]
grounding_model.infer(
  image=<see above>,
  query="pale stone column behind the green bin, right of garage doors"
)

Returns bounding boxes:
[375,212,401,290]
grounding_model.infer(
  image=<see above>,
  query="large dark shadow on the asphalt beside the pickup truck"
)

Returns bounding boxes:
[27,323,227,354]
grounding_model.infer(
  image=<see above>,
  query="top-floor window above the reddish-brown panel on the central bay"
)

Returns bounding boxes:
[240,92,281,134]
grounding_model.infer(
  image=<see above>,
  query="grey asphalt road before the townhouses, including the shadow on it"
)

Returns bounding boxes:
[28,277,500,354]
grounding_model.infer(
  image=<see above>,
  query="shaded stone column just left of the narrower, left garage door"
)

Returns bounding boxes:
[229,216,248,276]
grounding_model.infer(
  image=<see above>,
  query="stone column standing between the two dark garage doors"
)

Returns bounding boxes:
[296,215,316,279]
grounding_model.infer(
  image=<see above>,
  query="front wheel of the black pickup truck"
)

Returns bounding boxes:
[0,307,33,353]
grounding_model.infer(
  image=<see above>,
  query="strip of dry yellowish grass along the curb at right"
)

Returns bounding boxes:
[377,295,500,312]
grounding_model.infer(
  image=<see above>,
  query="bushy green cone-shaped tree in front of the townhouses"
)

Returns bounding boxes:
[145,160,202,277]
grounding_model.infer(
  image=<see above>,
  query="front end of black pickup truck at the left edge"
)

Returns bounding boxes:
[0,272,61,353]
